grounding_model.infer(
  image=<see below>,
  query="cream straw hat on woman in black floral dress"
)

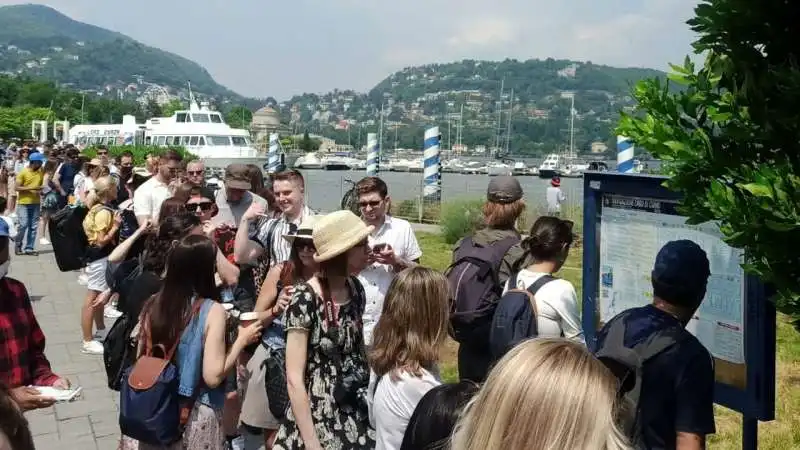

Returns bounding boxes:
[312,210,375,262]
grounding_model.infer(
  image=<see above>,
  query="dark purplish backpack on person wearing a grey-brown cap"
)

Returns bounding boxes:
[445,236,519,347]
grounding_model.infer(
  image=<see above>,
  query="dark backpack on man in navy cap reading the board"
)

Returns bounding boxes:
[594,311,689,448]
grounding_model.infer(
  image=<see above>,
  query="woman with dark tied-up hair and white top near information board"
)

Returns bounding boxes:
[505,216,583,343]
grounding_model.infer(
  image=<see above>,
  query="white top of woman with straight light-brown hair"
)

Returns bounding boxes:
[368,369,442,450]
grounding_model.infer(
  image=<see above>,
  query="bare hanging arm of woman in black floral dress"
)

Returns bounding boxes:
[286,328,322,450]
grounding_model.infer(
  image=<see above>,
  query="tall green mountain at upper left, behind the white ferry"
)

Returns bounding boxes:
[0,5,238,97]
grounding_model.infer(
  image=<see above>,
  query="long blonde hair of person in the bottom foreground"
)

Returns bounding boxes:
[451,338,631,450]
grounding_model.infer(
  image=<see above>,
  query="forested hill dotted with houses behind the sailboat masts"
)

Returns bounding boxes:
[279,59,664,154]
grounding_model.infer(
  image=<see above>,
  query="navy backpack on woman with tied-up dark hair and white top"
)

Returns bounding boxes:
[489,273,557,361]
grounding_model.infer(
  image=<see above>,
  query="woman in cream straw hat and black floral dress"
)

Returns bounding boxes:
[273,211,375,450]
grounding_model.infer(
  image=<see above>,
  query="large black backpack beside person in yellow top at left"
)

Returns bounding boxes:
[48,206,89,272]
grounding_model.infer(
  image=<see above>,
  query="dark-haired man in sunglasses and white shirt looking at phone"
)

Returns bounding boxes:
[356,177,422,345]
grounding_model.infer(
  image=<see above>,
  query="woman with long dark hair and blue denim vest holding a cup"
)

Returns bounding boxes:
[120,235,262,450]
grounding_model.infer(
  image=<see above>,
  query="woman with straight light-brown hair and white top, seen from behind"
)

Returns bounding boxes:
[369,266,449,450]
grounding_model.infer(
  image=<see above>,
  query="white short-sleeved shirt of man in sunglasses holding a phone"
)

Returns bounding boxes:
[358,215,422,345]
